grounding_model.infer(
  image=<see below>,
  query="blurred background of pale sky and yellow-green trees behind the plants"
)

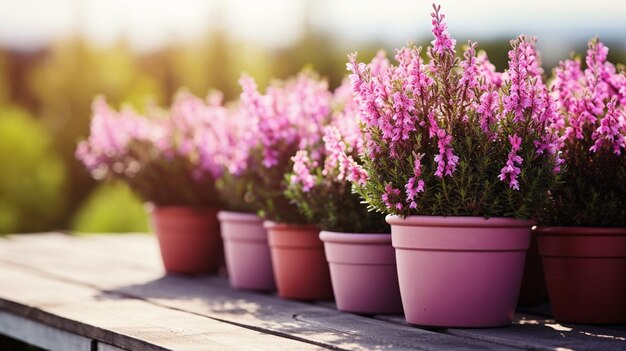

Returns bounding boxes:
[0,0,626,234]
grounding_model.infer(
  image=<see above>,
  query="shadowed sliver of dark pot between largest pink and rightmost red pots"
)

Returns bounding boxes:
[517,230,548,306]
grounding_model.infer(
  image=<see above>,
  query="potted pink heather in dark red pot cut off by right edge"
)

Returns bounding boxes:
[538,39,626,324]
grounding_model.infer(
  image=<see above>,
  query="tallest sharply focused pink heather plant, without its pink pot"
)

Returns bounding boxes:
[347,5,562,218]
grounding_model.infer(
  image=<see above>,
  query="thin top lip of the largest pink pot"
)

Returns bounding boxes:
[385,214,537,228]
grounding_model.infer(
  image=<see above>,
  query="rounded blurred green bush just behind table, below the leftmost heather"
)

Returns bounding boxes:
[72,183,148,233]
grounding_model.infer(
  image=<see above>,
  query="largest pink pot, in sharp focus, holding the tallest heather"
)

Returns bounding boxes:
[386,216,533,327]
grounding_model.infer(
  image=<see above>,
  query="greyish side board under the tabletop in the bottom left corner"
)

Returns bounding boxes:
[0,311,92,351]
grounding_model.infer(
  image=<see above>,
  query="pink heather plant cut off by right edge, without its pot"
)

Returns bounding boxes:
[546,39,626,227]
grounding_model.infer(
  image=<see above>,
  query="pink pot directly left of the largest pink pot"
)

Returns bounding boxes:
[320,231,402,313]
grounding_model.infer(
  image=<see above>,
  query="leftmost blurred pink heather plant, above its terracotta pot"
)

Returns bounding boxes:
[76,93,226,207]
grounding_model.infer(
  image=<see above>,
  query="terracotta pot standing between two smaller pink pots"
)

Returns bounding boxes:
[263,221,333,300]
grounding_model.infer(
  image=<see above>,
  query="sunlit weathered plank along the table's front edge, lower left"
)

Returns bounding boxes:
[0,262,319,350]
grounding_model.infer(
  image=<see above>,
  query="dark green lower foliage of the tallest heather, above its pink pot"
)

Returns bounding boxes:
[356,113,558,219]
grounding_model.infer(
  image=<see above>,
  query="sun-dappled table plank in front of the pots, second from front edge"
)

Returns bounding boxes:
[0,237,506,350]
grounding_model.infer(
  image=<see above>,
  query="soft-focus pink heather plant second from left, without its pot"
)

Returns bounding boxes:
[220,72,333,224]
